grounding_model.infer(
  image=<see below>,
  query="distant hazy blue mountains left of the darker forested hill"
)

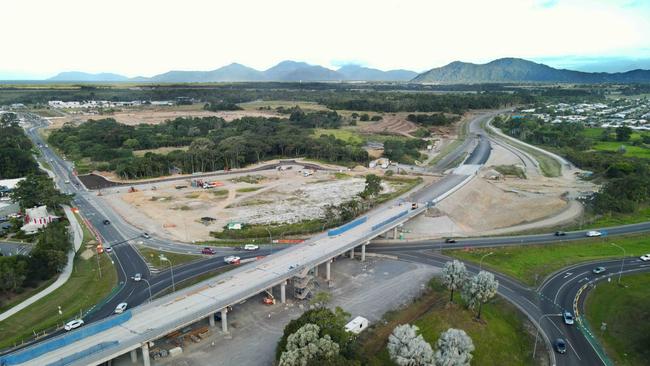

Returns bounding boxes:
[48,61,418,83]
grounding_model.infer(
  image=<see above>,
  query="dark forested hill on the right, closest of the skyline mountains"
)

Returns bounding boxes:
[412,58,650,84]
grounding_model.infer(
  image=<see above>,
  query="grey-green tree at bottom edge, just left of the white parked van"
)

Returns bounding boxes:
[279,323,339,366]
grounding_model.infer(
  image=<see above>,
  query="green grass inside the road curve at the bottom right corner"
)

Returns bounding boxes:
[585,273,650,366]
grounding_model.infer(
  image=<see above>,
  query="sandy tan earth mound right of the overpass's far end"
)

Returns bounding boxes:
[404,140,595,239]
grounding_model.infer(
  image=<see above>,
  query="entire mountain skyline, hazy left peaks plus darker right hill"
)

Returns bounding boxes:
[48,58,650,84]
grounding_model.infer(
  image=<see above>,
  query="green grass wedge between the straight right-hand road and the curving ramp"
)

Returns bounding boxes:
[444,235,650,285]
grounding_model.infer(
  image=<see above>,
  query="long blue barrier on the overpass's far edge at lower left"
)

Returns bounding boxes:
[0,310,131,366]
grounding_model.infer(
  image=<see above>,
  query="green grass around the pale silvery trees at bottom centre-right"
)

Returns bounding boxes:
[360,280,534,366]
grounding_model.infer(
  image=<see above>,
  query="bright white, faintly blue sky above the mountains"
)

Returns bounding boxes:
[0,0,650,80]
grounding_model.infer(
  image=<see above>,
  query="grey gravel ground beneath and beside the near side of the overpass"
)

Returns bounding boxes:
[113,257,438,366]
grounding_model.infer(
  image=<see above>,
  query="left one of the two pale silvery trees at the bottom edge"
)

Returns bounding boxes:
[386,324,433,366]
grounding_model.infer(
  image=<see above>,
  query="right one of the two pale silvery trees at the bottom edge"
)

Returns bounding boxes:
[433,328,474,366]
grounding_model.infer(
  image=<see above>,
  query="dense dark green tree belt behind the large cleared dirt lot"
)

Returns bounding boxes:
[49,110,368,179]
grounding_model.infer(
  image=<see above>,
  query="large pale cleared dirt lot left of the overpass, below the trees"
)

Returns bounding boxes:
[103,165,395,241]
